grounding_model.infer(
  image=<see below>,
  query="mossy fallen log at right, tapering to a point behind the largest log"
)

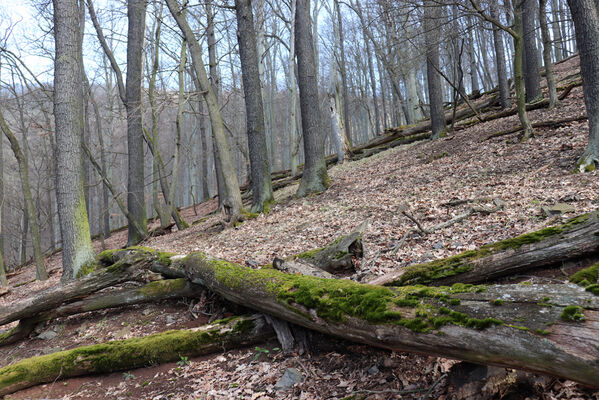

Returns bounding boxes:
[369,212,599,286]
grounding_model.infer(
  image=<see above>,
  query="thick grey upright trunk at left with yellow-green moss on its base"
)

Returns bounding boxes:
[53,0,94,282]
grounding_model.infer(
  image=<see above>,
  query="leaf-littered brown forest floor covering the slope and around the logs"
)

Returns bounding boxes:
[0,54,599,400]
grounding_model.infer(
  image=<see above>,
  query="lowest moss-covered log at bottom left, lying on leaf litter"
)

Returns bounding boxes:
[0,316,273,396]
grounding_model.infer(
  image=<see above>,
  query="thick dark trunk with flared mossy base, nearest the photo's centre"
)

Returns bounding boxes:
[295,0,330,197]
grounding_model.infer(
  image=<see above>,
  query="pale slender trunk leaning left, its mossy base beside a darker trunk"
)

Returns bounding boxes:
[167,0,242,224]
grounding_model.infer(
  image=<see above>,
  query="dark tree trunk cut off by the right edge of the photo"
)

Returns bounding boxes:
[568,0,599,171]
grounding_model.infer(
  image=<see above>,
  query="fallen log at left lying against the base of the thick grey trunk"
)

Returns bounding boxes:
[0,248,175,326]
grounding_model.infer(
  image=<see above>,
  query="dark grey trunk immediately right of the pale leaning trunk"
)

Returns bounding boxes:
[235,0,274,212]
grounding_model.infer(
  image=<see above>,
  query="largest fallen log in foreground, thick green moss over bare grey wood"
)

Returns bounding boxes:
[185,253,599,387]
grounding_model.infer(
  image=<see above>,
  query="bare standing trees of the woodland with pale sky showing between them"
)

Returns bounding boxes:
[0,0,599,282]
